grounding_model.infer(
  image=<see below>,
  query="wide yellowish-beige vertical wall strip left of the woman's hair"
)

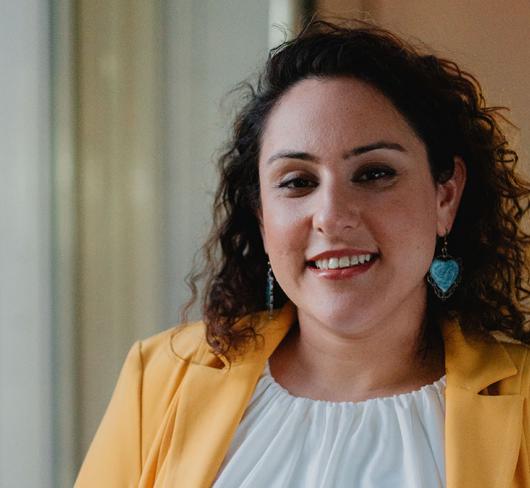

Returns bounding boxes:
[75,0,164,457]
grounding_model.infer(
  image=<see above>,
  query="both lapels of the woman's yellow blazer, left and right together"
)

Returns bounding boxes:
[163,303,523,488]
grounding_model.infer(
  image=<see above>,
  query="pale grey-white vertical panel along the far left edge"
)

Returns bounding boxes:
[0,0,52,488]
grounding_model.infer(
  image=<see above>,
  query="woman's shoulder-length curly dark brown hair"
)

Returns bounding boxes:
[183,20,530,355]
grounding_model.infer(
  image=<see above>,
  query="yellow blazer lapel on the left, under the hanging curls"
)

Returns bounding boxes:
[161,305,294,488]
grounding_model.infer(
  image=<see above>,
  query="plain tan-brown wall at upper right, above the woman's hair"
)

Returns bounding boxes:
[318,0,530,170]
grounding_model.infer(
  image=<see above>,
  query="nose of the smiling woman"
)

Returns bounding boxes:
[313,186,360,236]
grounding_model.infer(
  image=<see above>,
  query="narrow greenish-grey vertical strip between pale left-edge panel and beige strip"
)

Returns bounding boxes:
[50,0,77,488]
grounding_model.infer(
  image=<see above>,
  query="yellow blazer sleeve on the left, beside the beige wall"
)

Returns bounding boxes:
[74,342,143,488]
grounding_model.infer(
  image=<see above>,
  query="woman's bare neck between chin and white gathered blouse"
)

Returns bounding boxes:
[270,306,445,402]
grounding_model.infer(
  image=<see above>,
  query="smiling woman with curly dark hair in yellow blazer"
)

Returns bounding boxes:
[77,21,530,488]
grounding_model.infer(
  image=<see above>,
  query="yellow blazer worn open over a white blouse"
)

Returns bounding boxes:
[75,305,530,488]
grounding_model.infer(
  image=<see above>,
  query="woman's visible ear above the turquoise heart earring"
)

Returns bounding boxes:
[436,156,467,236]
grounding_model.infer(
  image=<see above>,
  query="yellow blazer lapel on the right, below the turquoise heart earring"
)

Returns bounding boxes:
[444,322,523,488]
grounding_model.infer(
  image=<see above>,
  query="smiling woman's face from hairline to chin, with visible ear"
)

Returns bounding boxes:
[259,78,460,336]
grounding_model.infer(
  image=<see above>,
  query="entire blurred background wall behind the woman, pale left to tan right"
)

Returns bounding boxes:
[0,0,530,488]
